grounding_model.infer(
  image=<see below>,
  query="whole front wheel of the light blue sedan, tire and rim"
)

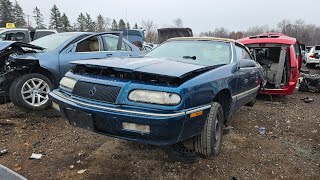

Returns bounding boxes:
[10,73,53,111]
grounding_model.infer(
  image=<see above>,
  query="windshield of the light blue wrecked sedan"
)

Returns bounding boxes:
[30,33,74,50]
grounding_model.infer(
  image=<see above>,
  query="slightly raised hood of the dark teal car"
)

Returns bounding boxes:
[71,57,208,78]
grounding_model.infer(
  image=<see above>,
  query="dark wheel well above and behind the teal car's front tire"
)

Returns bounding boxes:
[213,89,232,121]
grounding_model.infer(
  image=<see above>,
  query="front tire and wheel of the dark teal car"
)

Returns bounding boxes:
[193,102,224,158]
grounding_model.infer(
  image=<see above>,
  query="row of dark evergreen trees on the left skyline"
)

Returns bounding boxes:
[0,0,142,32]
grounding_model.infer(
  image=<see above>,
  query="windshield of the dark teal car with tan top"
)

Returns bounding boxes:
[146,40,231,66]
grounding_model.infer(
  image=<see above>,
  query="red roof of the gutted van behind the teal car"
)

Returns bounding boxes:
[238,33,297,45]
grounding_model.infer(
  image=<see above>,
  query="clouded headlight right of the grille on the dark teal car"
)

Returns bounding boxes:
[128,90,181,105]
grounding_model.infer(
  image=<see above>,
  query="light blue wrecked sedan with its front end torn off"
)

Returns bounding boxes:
[0,32,140,110]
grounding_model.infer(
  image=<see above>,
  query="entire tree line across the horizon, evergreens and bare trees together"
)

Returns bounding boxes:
[0,0,320,45]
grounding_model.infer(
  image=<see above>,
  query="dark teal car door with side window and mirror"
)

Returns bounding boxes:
[235,44,259,107]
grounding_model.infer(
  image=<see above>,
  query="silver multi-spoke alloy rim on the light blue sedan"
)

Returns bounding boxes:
[21,78,50,107]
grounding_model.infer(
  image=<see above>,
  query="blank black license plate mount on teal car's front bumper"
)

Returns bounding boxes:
[67,109,94,131]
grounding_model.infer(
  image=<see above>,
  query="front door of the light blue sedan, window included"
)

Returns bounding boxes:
[59,35,121,78]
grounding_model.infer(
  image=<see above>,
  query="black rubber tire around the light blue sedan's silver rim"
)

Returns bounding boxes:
[9,73,53,111]
